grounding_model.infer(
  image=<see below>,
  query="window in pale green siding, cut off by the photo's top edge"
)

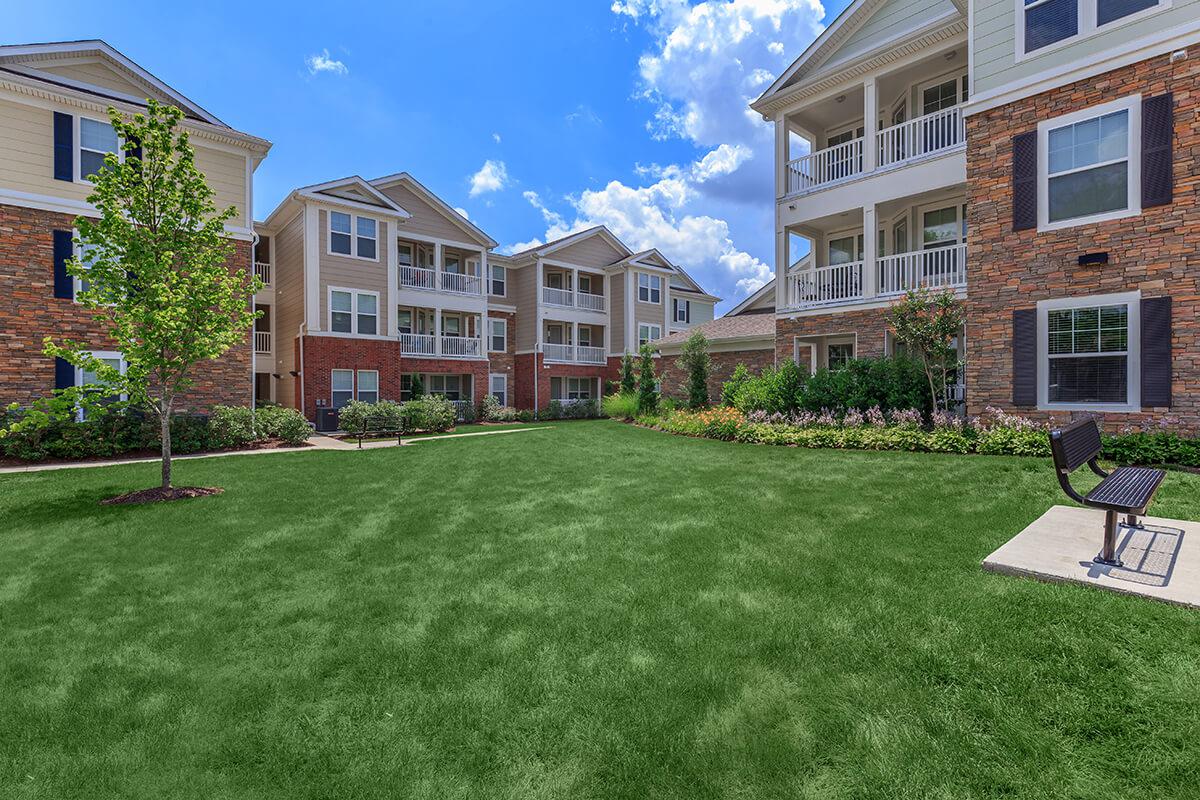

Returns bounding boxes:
[1016,0,1171,59]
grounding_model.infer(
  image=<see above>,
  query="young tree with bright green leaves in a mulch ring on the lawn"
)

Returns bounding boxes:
[44,100,262,492]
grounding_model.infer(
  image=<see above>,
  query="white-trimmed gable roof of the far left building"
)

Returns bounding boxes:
[0,38,233,130]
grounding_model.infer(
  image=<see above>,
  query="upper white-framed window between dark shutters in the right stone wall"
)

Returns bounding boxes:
[1038,96,1141,230]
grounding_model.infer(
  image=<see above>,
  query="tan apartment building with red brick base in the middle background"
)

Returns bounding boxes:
[254,173,719,428]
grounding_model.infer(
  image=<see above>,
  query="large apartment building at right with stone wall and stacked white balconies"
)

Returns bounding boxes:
[752,0,1200,429]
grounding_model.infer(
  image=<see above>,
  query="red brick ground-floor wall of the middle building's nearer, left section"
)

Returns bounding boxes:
[295,336,490,421]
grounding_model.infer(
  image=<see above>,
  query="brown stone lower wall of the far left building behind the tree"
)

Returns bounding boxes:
[0,205,252,410]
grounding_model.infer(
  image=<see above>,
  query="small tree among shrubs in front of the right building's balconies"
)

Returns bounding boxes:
[888,289,965,410]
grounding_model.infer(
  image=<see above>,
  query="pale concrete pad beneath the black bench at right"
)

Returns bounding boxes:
[983,506,1200,608]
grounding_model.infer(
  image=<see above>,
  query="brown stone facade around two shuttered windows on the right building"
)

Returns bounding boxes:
[966,47,1200,432]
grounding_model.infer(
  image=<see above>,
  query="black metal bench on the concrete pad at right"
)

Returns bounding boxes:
[1050,419,1166,566]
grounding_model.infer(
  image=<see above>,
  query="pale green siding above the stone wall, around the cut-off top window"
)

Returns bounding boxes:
[970,0,1200,95]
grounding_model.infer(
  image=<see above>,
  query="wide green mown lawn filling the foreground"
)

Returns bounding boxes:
[0,421,1200,800]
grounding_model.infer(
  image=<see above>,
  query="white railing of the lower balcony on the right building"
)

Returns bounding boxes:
[787,245,967,309]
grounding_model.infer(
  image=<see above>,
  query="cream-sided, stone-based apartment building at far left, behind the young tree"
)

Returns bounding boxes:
[0,41,271,409]
